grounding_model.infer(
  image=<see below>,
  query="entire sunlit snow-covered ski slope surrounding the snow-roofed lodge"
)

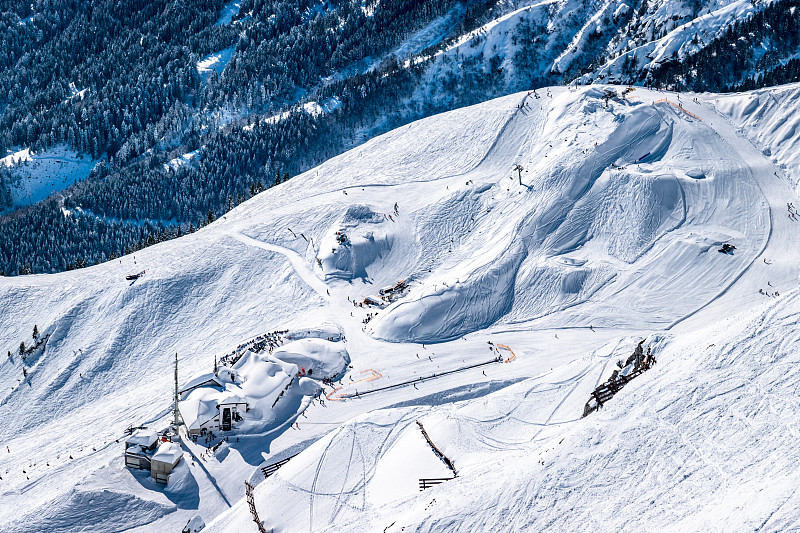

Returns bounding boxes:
[0,81,800,532]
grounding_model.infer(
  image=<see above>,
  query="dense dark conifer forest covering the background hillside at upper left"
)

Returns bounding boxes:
[0,0,468,275]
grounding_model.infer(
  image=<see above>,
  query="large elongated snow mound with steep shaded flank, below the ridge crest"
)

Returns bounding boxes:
[369,87,700,343]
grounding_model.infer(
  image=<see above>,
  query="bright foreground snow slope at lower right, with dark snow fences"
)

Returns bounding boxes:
[217,290,800,532]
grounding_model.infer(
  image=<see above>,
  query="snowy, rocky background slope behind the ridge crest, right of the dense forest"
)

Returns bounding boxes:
[417,0,770,101]
